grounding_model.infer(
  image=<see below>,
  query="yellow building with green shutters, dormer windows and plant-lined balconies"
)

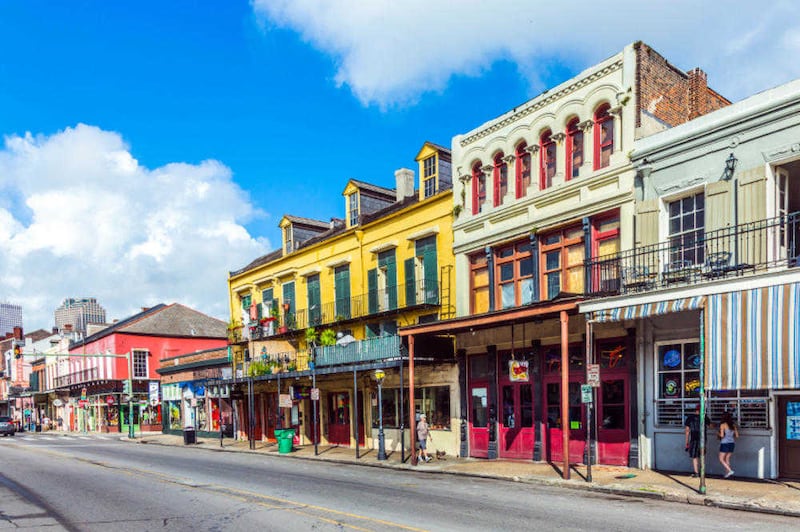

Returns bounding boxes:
[228,143,458,453]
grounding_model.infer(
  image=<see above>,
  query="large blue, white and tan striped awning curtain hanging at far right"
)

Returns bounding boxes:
[706,283,800,390]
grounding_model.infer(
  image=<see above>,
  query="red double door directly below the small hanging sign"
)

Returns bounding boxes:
[499,382,536,458]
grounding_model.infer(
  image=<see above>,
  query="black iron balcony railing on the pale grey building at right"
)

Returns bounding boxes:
[587,212,800,296]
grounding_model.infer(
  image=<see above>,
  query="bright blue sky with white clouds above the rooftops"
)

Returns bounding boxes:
[0,0,800,331]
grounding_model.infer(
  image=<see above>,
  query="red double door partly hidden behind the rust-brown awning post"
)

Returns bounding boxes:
[544,377,586,464]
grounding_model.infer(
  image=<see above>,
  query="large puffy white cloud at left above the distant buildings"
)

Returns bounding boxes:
[0,124,269,330]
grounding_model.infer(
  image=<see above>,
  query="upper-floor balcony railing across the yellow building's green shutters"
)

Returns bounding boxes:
[242,279,442,343]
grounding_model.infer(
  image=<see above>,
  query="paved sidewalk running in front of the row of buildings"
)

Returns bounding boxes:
[126,433,800,517]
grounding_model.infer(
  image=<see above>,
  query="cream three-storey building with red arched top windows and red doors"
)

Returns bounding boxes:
[401,43,728,474]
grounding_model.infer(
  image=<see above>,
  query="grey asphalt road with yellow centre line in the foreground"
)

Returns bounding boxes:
[0,435,800,532]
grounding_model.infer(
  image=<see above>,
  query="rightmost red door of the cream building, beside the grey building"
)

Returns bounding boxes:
[597,374,631,466]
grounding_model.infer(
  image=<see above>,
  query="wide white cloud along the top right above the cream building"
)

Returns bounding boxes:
[252,0,800,107]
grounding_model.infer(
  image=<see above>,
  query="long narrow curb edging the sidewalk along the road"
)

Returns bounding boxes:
[121,437,800,517]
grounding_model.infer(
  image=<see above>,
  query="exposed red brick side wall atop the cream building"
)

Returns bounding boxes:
[635,42,731,127]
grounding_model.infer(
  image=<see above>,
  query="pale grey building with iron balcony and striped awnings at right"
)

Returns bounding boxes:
[581,77,800,478]
